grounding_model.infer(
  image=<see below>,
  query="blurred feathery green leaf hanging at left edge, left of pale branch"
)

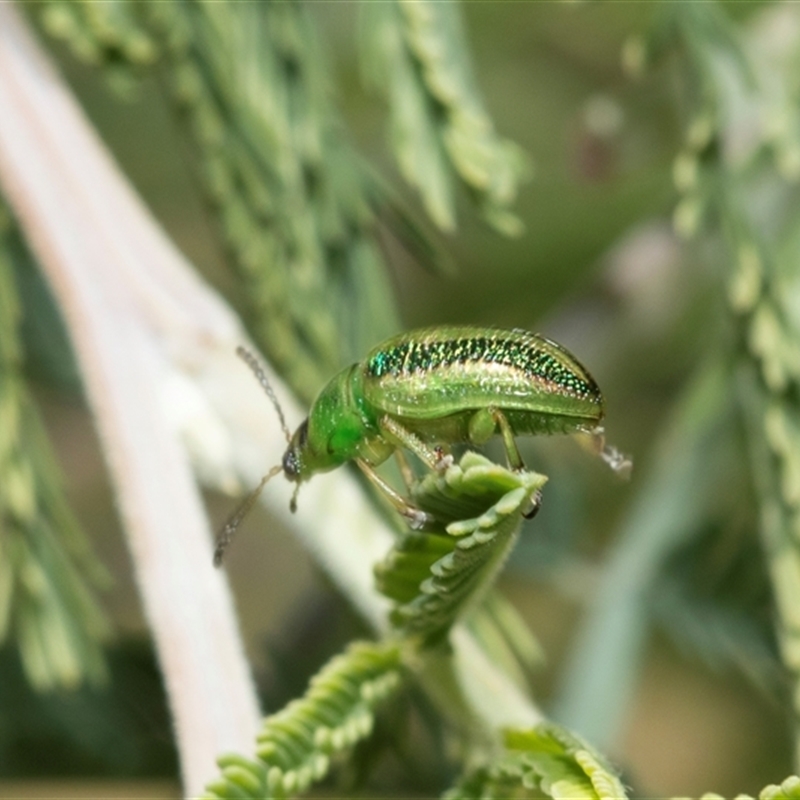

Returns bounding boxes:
[0,207,108,690]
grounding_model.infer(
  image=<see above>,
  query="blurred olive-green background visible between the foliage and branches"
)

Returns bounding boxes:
[0,1,791,796]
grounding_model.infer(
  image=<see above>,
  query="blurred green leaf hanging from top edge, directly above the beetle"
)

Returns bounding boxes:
[360,0,528,235]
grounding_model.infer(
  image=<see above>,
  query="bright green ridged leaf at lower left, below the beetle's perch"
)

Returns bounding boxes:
[203,642,401,800]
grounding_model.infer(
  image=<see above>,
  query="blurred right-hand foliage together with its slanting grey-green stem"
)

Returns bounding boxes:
[559,3,800,760]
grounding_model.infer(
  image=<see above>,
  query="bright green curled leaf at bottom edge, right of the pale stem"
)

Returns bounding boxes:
[444,723,627,800]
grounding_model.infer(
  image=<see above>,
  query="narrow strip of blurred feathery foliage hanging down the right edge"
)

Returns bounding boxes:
[648,0,800,763]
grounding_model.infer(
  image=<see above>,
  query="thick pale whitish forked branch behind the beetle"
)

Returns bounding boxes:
[0,4,539,795]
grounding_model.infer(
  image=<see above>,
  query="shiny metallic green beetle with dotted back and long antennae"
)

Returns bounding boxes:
[215,327,630,563]
